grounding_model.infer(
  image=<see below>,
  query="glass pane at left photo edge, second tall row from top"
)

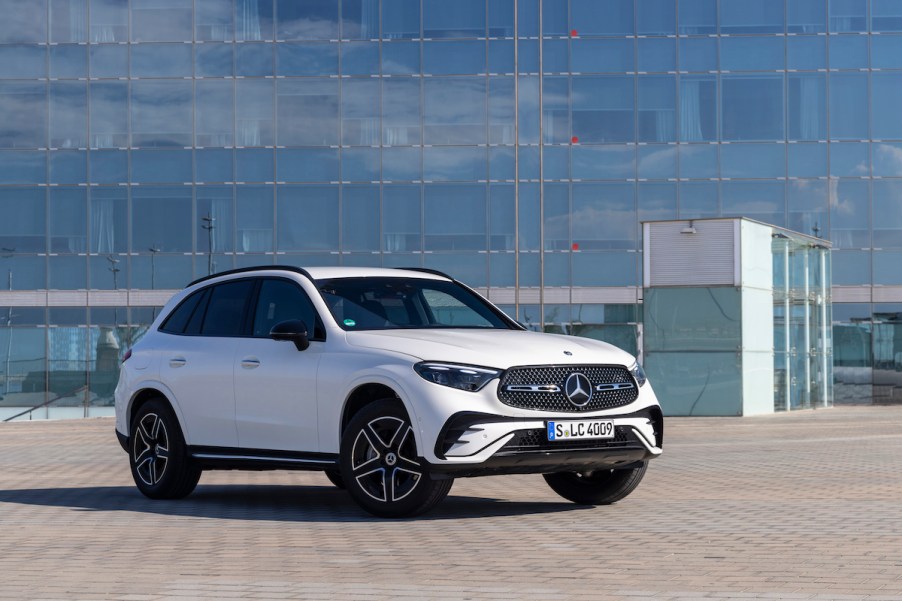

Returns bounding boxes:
[0,82,47,148]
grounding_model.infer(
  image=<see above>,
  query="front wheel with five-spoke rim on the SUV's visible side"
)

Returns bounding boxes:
[340,399,454,518]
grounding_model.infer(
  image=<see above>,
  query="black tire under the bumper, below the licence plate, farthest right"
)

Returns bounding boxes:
[544,461,648,505]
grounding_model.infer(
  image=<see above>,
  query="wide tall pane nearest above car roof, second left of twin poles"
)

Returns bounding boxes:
[424,184,486,250]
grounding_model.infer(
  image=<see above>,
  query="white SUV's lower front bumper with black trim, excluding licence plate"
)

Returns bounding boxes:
[430,406,664,476]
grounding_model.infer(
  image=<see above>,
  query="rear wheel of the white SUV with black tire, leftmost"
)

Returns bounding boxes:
[128,398,201,499]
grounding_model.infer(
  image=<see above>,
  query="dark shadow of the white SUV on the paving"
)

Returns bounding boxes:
[0,485,589,522]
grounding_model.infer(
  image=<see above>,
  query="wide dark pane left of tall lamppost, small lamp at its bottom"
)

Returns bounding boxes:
[132,186,194,252]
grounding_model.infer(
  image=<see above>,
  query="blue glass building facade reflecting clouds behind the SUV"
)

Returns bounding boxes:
[0,0,902,418]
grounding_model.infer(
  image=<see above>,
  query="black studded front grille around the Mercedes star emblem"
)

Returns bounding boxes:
[498,365,639,413]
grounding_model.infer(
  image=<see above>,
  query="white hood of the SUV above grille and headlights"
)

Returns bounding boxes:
[347,329,634,369]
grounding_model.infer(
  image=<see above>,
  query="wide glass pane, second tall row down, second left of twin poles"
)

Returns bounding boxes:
[423,77,486,144]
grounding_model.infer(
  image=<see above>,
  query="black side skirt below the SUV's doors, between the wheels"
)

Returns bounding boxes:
[188,446,338,471]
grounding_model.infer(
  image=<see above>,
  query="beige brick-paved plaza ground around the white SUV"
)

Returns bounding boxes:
[0,407,902,601]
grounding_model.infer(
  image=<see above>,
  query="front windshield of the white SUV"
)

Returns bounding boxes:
[317,278,515,331]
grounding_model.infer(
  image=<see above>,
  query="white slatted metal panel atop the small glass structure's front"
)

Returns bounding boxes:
[645,219,739,287]
